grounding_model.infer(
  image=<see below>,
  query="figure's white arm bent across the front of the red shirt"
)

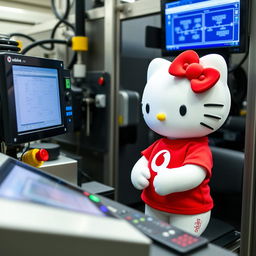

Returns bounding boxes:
[153,164,206,196]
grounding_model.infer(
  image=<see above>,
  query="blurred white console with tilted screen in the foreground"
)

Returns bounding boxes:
[0,154,150,256]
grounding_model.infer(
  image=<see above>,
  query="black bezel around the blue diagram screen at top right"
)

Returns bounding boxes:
[161,0,249,56]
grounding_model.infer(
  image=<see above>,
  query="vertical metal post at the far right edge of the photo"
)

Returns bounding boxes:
[240,1,256,256]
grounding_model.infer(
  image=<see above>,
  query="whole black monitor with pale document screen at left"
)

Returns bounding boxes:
[0,53,73,145]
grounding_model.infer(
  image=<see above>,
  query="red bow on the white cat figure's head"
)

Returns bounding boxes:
[168,50,220,93]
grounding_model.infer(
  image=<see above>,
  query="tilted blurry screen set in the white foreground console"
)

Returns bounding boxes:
[0,160,106,216]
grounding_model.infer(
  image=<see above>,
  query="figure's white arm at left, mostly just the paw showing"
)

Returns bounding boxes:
[131,156,150,190]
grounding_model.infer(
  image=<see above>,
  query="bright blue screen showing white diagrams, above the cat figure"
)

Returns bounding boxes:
[165,0,240,50]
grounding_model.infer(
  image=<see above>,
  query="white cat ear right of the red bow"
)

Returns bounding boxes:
[200,54,228,83]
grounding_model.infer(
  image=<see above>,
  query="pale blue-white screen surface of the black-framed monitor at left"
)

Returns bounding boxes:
[12,65,62,133]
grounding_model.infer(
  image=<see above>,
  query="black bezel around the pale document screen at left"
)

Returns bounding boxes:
[0,53,66,145]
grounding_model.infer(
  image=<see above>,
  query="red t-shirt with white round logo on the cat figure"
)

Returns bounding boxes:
[141,137,213,215]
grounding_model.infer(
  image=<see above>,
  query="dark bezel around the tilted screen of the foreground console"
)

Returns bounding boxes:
[0,157,115,217]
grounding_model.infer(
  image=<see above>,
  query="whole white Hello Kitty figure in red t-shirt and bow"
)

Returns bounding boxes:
[131,50,231,236]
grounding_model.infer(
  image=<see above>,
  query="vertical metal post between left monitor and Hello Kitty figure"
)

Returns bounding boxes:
[104,0,120,187]
